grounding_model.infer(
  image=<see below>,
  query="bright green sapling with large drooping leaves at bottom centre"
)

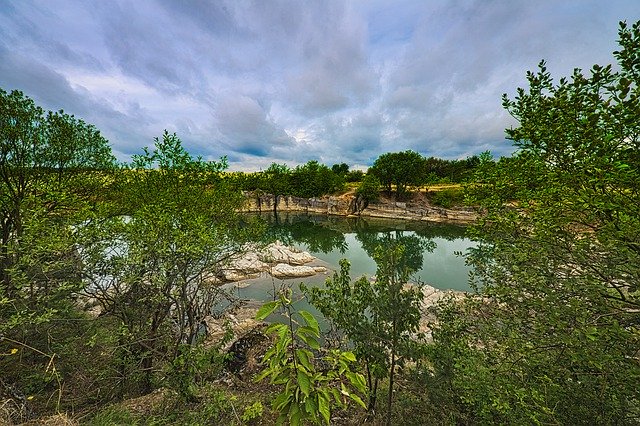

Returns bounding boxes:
[256,290,366,425]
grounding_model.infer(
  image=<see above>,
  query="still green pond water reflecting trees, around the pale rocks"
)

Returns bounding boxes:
[226,213,474,301]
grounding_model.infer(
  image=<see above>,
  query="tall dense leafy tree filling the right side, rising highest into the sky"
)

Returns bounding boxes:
[434,22,640,424]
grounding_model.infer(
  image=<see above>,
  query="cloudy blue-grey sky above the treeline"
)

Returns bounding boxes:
[0,0,640,171]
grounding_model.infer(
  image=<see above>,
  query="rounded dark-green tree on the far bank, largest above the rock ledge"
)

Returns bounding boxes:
[368,151,424,198]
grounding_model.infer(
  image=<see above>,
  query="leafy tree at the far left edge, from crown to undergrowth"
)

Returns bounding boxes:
[0,89,113,418]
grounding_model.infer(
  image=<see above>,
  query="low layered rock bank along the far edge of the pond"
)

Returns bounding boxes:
[242,193,478,225]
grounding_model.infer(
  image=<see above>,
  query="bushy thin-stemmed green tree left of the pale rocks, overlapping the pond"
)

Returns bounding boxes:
[90,131,252,391]
